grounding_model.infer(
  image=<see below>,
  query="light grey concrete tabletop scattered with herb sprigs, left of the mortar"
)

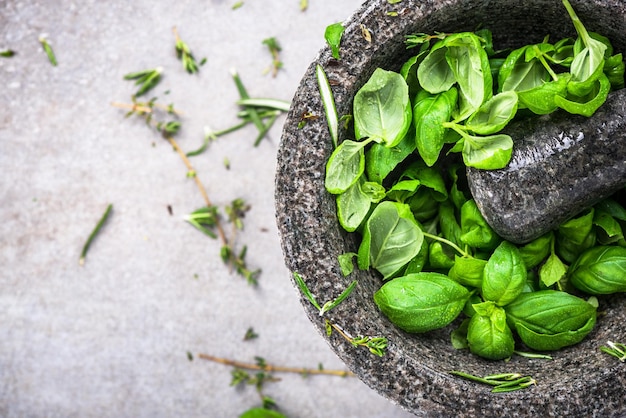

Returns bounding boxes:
[0,0,409,417]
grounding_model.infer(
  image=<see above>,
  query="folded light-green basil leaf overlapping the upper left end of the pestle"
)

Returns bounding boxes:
[463,134,513,170]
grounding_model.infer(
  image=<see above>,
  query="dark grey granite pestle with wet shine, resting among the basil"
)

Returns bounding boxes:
[467,89,626,244]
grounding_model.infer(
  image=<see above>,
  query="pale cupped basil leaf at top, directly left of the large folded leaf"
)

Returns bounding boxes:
[417,46,456,94]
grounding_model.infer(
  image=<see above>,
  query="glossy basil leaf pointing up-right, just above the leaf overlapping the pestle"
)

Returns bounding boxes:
[464,91,517,134]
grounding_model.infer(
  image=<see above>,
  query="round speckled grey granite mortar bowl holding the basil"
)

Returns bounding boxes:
[275,0,626,417]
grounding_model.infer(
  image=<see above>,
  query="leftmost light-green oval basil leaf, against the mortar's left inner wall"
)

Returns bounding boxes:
[324,140,365,194]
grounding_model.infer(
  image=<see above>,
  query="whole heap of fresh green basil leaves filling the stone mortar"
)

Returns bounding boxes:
[325,0,626,359]
